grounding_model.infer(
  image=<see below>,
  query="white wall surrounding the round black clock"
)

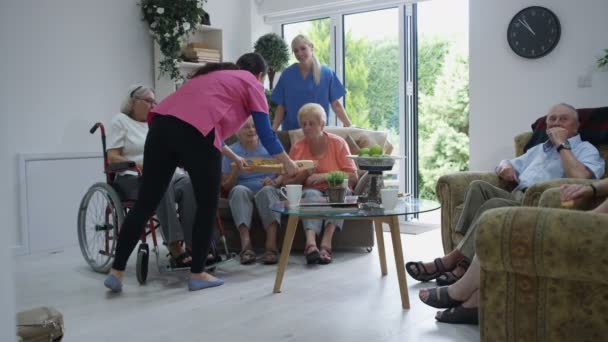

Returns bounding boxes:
[469,0,608,170]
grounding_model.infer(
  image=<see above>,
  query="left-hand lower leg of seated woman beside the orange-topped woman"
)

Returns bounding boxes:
[228,185,256,265]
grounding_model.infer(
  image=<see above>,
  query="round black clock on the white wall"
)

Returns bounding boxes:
[507,6,561,58]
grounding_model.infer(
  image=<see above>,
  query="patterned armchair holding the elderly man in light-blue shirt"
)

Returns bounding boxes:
[435,132,608,254]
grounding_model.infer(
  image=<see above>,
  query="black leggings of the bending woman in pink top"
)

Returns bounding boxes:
[112,115,222,273]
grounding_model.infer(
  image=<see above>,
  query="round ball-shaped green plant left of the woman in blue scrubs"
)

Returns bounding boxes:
[253,33,289,90]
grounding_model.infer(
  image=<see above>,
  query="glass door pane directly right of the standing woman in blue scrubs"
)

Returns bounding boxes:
[342,7,403,187]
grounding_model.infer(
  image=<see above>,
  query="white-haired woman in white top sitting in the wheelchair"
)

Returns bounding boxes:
[107,84,196,267]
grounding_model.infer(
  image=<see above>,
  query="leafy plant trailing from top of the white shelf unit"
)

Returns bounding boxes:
[140,0,207,81]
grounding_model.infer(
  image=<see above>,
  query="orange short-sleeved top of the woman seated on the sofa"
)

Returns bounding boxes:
[289,132,357,191]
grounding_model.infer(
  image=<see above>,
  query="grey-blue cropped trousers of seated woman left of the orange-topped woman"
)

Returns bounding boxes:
[228,185,281,229]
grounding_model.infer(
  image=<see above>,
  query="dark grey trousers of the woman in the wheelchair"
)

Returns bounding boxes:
[115,172,196,245]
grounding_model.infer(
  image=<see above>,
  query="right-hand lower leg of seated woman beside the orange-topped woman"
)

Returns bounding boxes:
[254,185,281,265]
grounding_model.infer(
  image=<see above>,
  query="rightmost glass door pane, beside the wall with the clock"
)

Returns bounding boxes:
[417,0,469,220]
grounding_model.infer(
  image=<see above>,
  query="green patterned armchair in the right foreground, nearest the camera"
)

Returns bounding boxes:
[476,189,608,342]
